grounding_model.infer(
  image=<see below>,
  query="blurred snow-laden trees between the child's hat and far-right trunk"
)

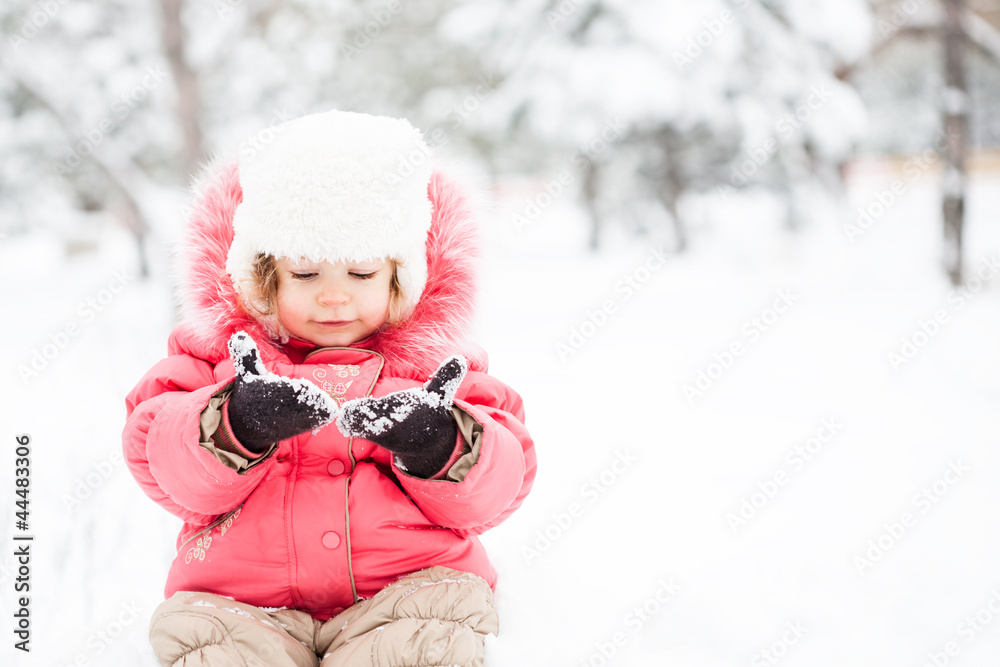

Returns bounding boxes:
[436,0,871,247]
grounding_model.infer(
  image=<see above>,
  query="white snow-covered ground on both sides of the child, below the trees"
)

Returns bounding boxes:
[0,163,1000,667]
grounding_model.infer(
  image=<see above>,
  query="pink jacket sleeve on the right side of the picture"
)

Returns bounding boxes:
[393,372,535,535]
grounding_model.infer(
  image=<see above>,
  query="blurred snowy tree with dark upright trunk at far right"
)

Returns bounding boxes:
[850,0,1000,285]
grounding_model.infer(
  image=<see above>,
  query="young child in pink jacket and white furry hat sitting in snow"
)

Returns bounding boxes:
[123,111,535,667]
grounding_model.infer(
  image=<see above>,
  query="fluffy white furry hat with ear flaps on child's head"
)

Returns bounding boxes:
[226,111,431,320]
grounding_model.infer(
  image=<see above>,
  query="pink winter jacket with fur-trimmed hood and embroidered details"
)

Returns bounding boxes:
[123,164,535,620]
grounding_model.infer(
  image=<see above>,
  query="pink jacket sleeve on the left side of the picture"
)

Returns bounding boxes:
[122,332,273,523]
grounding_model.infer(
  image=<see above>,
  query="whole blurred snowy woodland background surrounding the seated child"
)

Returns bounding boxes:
[0,0,1000,667]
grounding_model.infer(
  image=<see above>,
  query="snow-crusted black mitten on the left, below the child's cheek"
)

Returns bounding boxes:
[228,331,337,453]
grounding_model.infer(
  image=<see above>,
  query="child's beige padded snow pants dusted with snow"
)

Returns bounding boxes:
[149,567,497,667]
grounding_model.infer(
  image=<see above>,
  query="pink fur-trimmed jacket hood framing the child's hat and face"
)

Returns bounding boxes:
[174,160,487,381]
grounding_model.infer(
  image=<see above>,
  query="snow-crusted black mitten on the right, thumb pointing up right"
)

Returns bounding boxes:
[337,356,468,477]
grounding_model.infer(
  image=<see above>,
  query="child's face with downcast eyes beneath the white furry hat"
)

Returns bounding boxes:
[277,259,392,347]
